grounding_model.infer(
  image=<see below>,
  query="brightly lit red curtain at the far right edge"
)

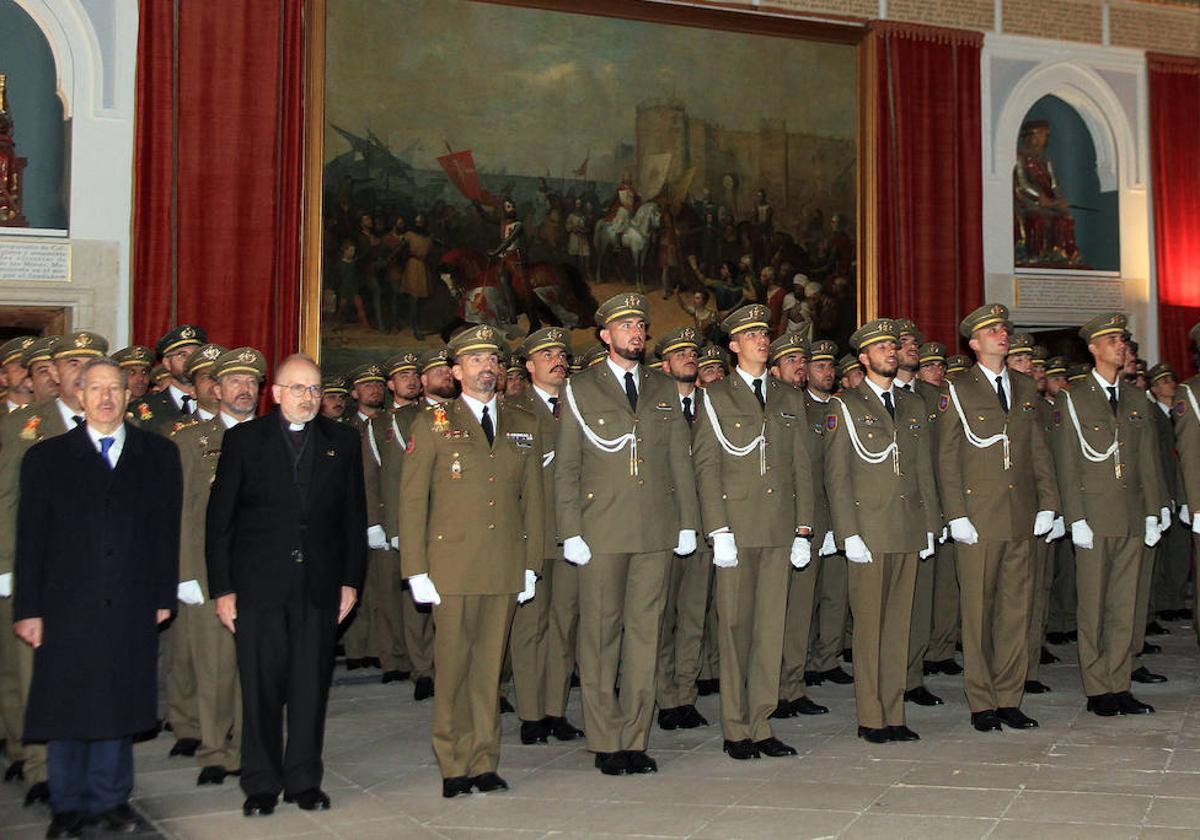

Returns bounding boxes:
[1146,54,1200,376]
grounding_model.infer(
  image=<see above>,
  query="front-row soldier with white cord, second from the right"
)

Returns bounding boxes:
[936,304,1060,732]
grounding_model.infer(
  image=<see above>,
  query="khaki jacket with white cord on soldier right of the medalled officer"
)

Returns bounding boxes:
[554,364,700,554]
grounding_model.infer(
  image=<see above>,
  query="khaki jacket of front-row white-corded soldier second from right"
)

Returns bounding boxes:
[935,365,1061,540]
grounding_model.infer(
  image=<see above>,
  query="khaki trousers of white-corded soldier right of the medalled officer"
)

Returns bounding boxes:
[580,551,671,752]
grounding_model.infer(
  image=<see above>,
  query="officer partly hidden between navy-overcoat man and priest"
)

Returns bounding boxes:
[169,347,266,785]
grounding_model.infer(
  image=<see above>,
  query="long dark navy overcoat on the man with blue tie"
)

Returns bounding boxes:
[13,424,181,740]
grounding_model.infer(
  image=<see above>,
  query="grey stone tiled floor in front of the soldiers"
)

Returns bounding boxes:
[0,623,1200,840]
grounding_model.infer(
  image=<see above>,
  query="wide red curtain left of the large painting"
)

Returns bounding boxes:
[133,0,304,362]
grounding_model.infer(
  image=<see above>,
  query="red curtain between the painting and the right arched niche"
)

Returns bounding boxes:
[868,22,983,348]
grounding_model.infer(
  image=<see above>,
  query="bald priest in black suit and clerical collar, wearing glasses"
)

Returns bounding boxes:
[205,355,367,816]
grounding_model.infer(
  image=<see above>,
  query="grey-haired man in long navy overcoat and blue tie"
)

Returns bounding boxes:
[13,355,182,838]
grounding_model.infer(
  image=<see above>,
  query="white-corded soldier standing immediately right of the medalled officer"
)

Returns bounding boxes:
[554,293,698,775]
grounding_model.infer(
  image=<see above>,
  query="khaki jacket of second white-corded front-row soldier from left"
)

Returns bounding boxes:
[695,373,814,548]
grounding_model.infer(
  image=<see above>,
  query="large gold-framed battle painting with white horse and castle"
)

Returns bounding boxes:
[302,0,865,370]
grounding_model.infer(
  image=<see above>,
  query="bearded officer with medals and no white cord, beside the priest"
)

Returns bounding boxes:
[401,324,545,797]
